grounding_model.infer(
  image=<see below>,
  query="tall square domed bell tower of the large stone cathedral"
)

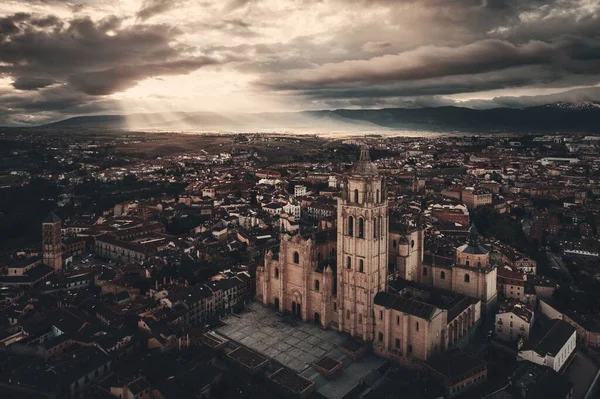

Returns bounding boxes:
[336,146,388,341]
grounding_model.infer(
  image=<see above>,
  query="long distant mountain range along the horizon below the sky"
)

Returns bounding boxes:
[36,103,600,133]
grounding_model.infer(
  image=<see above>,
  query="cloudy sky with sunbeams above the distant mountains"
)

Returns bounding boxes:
[0,0,600,126]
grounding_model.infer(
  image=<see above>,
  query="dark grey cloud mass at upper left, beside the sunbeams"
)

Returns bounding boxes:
[0,10,219,125]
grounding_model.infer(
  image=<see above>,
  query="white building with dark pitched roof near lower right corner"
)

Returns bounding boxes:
[517,319,577,372]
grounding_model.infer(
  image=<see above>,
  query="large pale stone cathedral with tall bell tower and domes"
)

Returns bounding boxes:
[256,147,496,364]
